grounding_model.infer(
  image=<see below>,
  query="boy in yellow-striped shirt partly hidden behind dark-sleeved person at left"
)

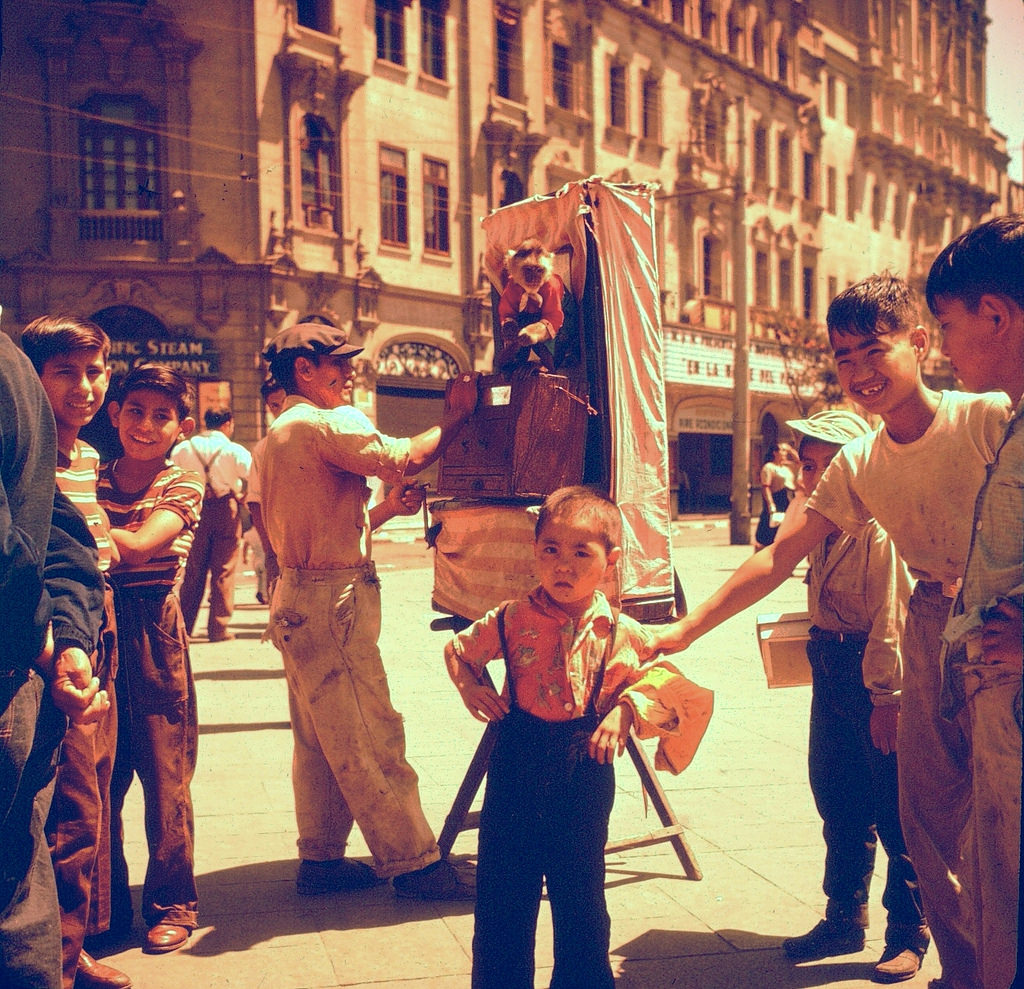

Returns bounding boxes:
[22,315,131,989]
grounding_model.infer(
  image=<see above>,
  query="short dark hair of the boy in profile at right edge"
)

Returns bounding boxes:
[925,213,1024,312]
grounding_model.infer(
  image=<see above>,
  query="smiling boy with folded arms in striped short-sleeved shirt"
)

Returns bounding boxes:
[98,364,204,954]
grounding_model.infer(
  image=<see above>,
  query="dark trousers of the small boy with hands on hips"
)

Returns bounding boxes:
[472,708,615,989]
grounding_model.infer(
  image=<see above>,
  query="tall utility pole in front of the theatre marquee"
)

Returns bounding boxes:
[729,96,751,546]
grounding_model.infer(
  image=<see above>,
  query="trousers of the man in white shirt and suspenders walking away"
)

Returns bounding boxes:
[181,495,242,639]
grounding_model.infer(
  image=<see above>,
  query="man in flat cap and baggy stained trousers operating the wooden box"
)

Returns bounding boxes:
[261,321,477,900]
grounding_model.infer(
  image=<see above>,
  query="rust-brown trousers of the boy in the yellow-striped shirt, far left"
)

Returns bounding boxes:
[46,586,118,989]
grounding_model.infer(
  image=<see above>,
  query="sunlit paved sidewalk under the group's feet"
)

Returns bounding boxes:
[97,518,939,989]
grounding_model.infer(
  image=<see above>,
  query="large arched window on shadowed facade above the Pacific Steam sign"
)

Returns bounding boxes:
[79,96,163,210]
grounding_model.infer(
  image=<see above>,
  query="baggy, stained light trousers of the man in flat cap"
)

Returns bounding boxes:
[270,563,440,877]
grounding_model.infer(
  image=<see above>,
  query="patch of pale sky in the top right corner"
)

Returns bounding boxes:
[986,0,1024,182]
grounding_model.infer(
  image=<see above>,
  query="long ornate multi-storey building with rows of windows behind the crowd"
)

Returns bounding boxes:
[0,0,1007,507]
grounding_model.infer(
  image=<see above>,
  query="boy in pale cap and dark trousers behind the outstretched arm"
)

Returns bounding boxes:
[782,409,931,983]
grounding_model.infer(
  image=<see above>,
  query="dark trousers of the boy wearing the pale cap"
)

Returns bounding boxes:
[807,639,924,947]
